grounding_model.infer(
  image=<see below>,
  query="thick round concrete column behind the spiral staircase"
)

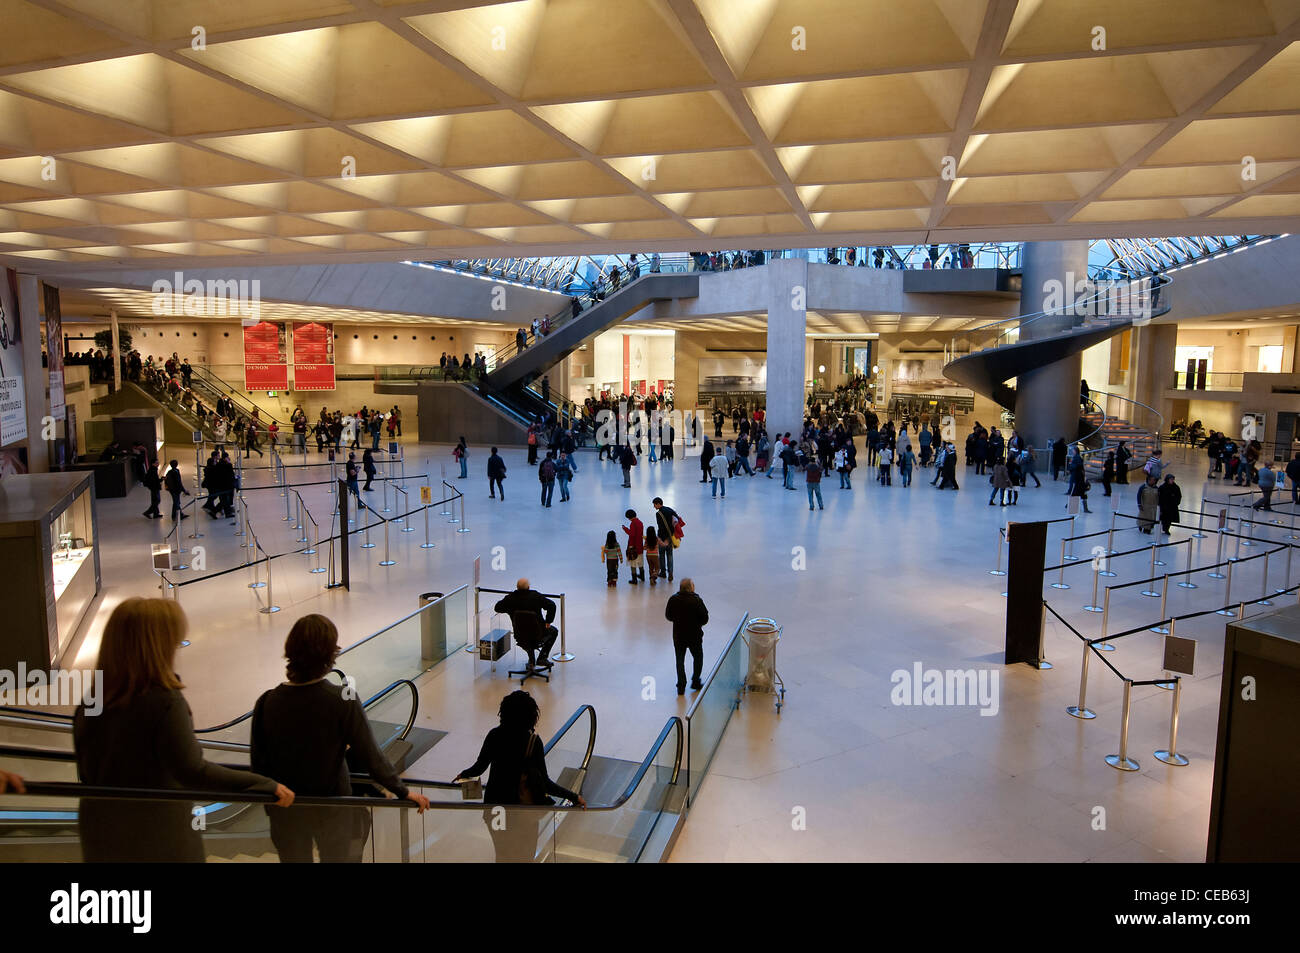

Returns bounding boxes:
[1015,241,1088,447]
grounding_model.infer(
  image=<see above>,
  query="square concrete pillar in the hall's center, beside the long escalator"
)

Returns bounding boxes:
[762,259,809,437]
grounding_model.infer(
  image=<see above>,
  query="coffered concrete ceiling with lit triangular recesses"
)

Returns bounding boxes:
[0,0,1300,272]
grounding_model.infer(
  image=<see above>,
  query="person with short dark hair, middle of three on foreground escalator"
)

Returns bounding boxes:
[250,614,429,863]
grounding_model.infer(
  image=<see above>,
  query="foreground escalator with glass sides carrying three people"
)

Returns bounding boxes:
[0,705,685,863]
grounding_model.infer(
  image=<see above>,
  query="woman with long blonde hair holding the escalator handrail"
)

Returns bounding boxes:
[73,598,294,863]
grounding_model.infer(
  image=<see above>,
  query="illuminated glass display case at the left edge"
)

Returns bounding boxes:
[0,472,100,670]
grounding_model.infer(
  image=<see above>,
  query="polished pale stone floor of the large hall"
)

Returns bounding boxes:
[50,439,1300,861]
